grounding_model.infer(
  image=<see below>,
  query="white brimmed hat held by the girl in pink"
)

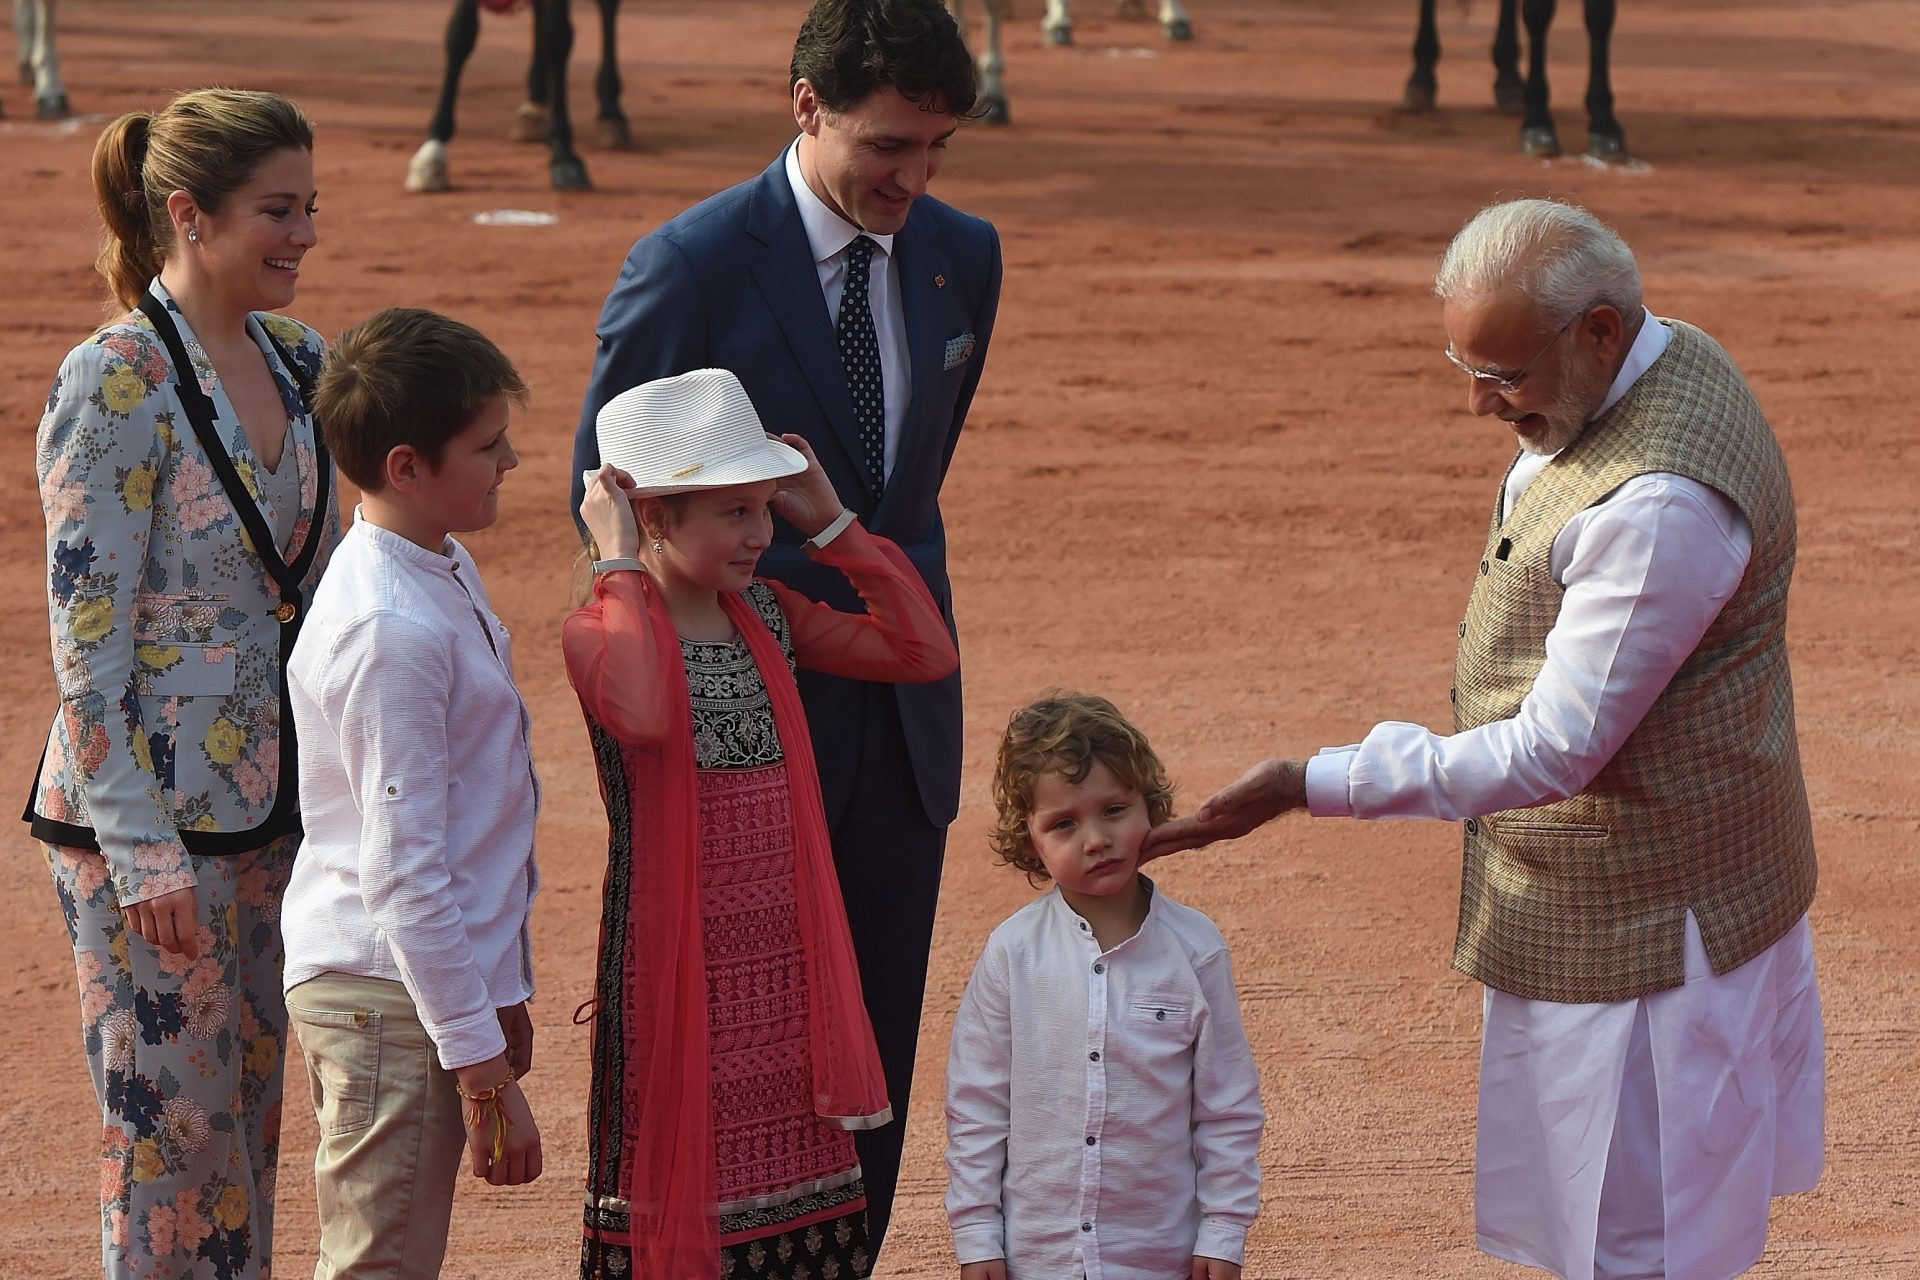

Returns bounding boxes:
[593,368,806,497]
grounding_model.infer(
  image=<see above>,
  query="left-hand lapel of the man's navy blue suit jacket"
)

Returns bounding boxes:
[747,152,875,498]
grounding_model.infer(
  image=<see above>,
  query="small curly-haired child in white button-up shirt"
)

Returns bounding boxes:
[947,695,1265,1280]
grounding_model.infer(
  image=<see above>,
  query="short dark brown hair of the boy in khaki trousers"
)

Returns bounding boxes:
[313,307,526,493]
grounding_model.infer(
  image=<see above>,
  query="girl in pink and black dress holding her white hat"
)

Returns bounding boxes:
[563,370,958,1280]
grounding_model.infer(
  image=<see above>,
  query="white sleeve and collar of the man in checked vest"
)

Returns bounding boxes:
[1308,311,1753,821]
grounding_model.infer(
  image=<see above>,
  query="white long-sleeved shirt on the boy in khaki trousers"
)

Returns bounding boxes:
[282,512,540,1071]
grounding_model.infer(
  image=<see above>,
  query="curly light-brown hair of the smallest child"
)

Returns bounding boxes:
[987,693,1173,885]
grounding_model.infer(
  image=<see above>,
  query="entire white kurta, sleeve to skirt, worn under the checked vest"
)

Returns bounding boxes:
[1308,313,1826,1280]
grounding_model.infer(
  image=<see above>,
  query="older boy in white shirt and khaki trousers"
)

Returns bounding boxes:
[282,309,541,1280]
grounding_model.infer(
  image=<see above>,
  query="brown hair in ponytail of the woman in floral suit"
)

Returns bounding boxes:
[94,88,313,311]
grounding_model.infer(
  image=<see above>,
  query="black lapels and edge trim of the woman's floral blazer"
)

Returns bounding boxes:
[23,292,334,856]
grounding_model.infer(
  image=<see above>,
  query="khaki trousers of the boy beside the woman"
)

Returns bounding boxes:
[286,973,467,1280]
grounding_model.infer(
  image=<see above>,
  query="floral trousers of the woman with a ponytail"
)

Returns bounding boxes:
[44,835,300,1280]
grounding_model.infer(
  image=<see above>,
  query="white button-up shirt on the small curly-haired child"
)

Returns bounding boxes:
[947,889,1265,1280]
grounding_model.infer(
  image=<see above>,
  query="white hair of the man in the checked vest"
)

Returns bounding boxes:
[1434,200,1640,328]
